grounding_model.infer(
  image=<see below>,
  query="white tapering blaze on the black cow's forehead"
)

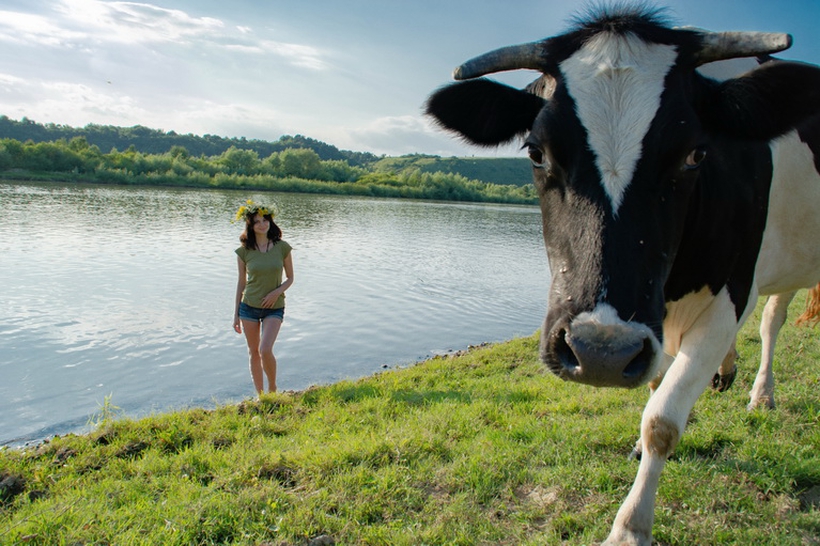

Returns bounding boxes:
[560,32,677,214]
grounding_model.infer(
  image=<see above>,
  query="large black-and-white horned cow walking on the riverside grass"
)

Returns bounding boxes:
[425,6,820,545]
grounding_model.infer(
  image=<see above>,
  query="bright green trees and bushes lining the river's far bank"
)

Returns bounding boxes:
[0,136,536,204]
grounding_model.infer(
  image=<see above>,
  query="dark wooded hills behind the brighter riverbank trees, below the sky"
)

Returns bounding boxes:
[0,115,532,186]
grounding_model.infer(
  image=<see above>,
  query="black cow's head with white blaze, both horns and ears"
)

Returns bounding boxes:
[427,5,816,387]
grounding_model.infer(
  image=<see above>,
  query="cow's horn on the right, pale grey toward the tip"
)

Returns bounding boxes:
[695,32,792,65]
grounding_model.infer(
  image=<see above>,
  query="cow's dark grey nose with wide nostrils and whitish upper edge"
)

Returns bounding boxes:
[552,324,655,387]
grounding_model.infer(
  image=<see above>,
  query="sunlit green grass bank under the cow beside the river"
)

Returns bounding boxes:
[0,292,820,546]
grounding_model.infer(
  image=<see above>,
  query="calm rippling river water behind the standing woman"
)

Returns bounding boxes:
[0,182,549,445]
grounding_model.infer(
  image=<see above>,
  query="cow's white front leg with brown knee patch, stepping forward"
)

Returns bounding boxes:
[604,290,738,546]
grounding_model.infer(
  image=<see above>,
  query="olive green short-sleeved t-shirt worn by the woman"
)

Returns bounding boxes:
[235,240,291,309]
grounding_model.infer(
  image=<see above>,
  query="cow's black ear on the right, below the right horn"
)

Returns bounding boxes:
[702,61,820,140]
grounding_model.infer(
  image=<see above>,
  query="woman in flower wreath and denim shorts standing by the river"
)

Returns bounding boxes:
[233,200,293,394]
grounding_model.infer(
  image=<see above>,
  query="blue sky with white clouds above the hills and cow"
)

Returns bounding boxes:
[0,0,820,157]
